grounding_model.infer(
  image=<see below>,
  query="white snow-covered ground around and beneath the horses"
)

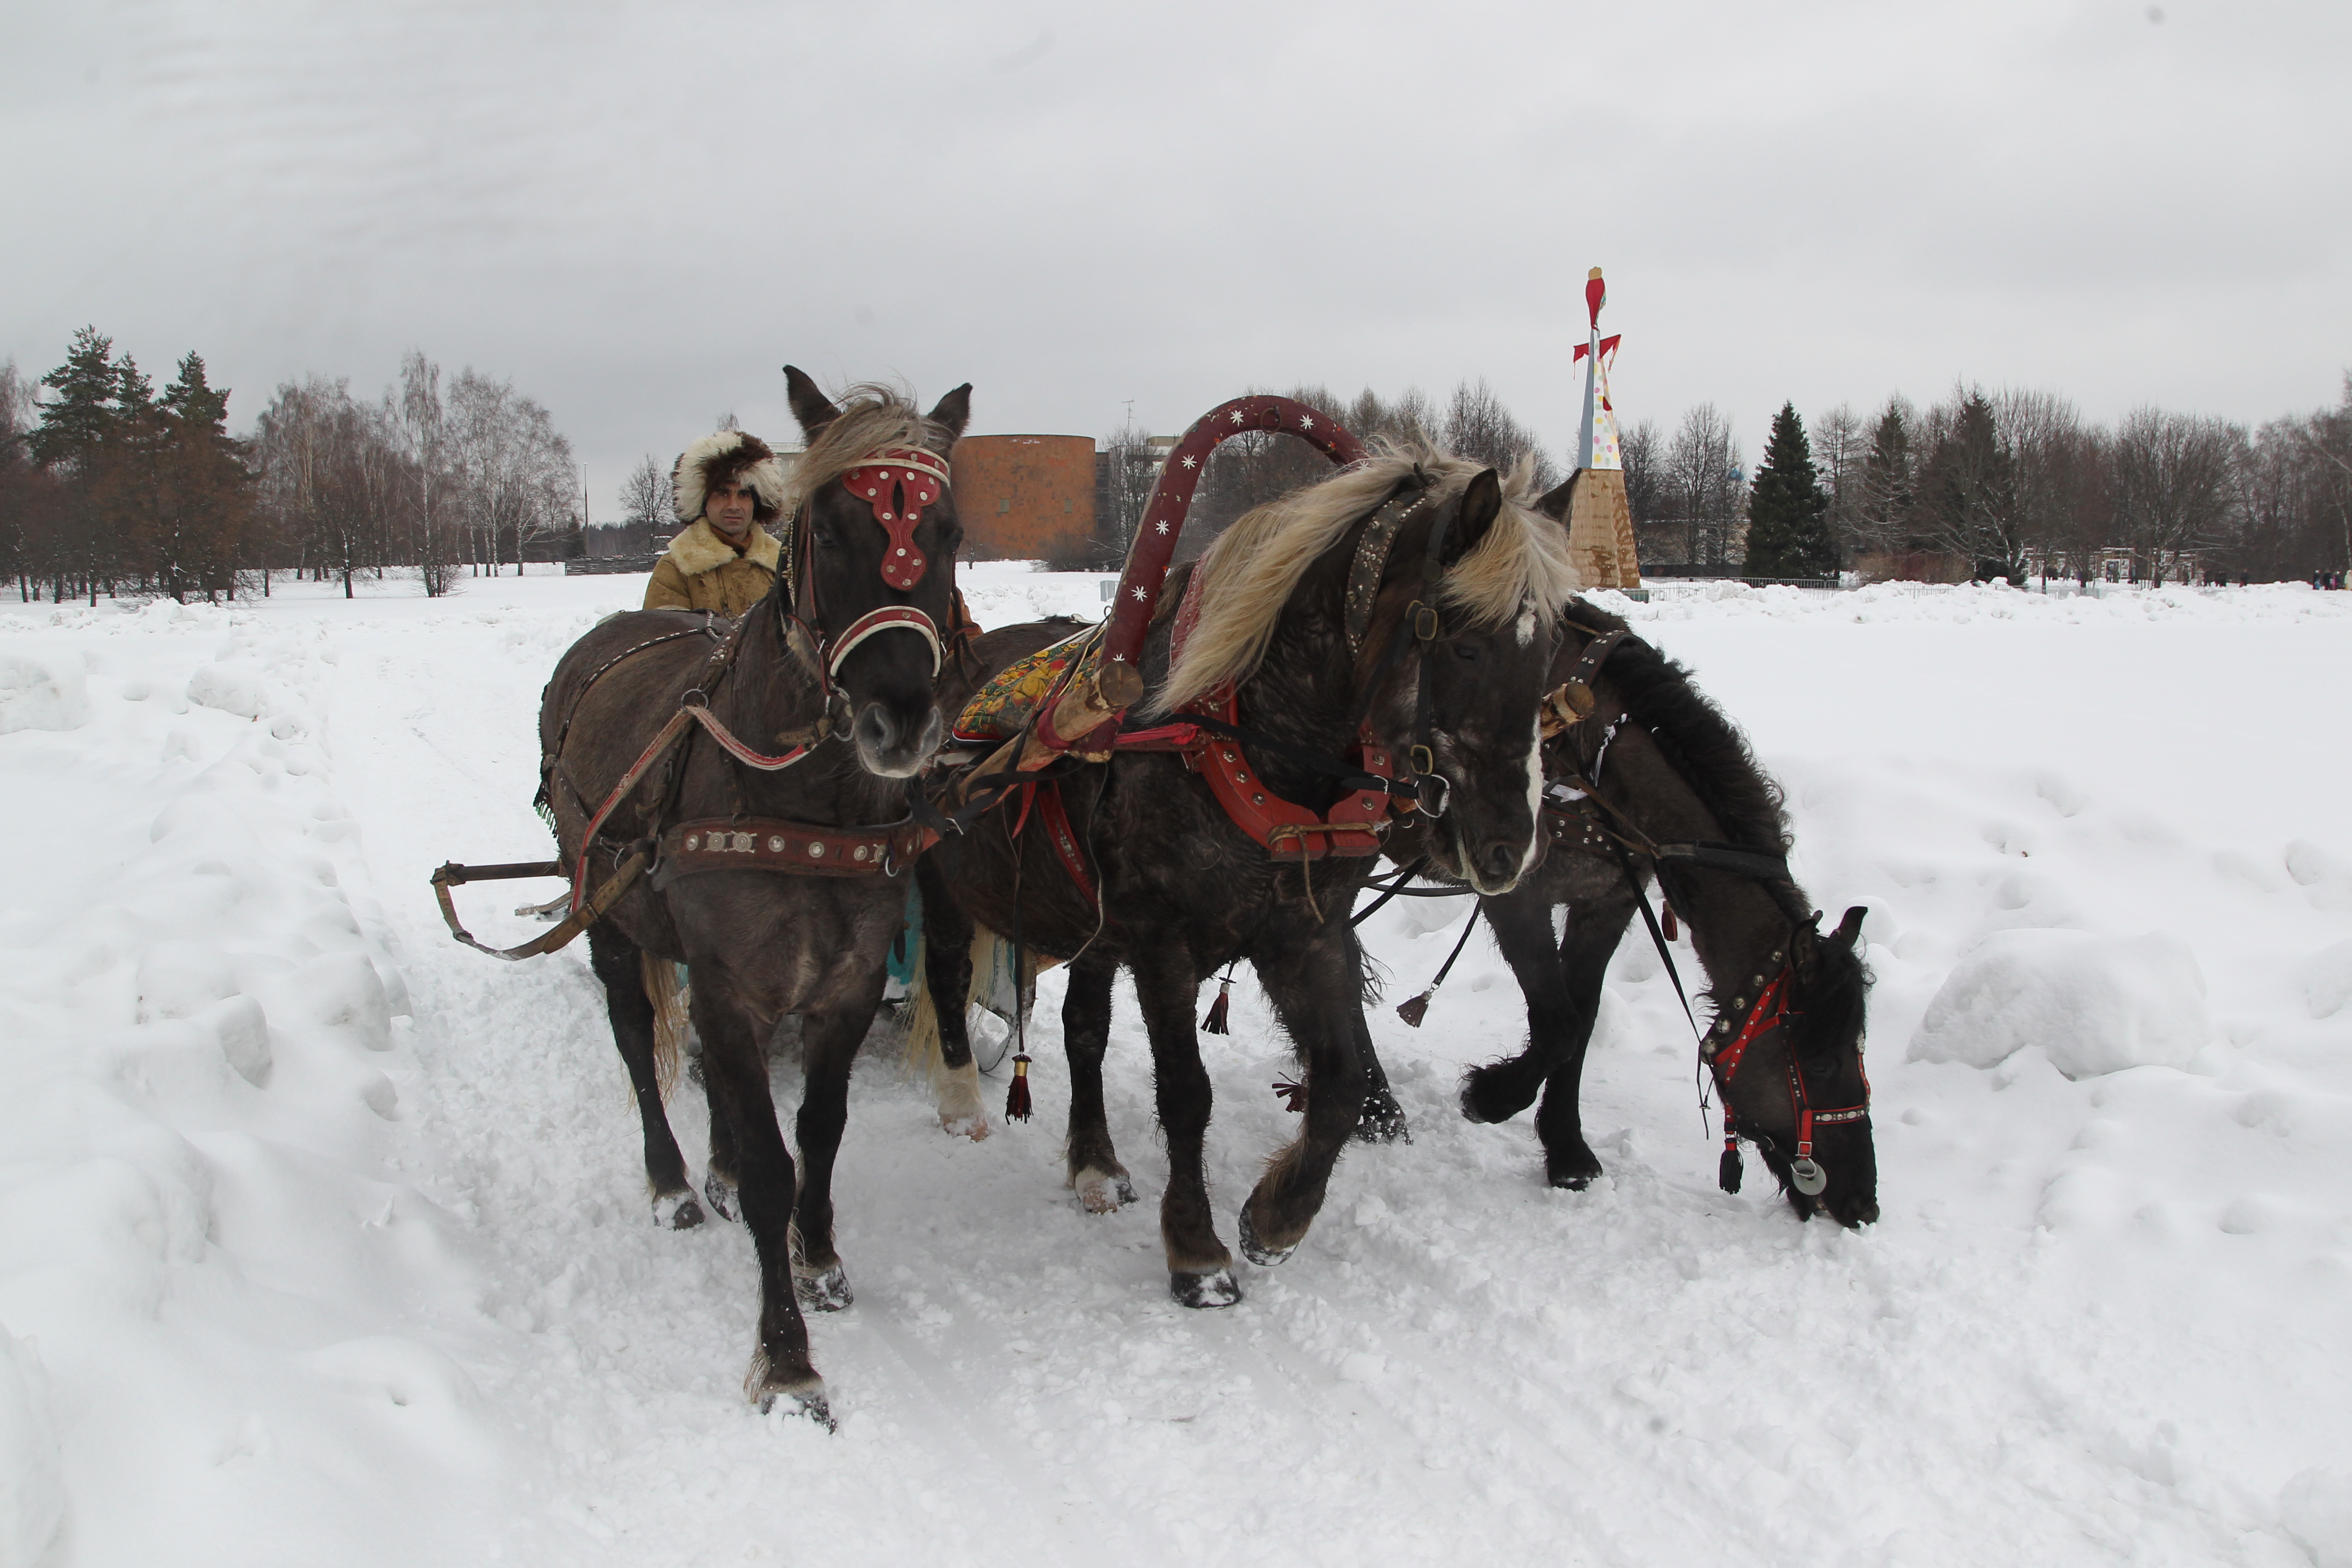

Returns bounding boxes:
[0,566,2352,1568]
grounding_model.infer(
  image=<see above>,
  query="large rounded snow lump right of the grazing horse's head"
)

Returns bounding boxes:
[1910,931,2213,1079]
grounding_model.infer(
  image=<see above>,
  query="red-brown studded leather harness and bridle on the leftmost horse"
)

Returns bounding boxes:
[433,447,962,959]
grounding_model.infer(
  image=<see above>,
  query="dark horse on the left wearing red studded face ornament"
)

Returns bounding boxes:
[539,369,971,1420]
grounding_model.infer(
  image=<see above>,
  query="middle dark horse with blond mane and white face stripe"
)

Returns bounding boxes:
[922,453,1571,1307]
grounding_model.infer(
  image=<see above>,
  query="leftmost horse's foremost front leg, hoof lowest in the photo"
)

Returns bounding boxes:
[694,982,833,1427]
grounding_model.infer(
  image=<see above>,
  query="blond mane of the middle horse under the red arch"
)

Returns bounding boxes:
[1150,444,1578,715]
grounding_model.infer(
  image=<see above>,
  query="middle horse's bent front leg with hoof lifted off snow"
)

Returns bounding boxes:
[1242,926,1369,1267]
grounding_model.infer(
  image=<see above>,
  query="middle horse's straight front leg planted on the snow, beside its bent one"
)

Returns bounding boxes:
[1134,940,1242,1307]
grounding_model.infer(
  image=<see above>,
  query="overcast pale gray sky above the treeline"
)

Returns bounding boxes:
[0,0,2352,517]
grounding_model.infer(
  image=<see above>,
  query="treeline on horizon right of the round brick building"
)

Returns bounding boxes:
[1101,374,2352,583]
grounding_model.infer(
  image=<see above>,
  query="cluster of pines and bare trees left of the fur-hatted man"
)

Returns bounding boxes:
[0,327,581,604]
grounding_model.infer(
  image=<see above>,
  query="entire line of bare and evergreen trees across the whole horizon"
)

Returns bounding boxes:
[0,327,2352,602]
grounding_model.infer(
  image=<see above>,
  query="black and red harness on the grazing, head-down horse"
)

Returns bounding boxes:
[1543,621,1870,1197]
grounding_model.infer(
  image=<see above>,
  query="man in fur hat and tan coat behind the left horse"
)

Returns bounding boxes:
[645,430,783,621]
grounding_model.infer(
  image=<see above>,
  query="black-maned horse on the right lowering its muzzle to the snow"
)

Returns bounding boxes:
[1390,600,1879,1225]
